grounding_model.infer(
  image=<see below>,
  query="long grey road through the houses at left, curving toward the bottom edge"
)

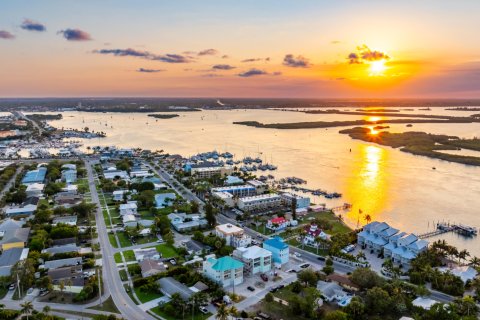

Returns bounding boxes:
[85,161,155,320]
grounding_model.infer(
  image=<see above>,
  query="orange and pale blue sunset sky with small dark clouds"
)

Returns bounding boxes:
[0,0,480,98]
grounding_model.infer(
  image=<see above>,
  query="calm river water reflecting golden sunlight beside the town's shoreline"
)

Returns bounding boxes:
[47,108,480,256]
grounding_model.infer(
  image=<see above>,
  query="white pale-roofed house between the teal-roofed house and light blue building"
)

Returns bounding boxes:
[233,246,272,275]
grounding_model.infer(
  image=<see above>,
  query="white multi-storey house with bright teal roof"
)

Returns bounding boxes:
[203,256,243,287]
